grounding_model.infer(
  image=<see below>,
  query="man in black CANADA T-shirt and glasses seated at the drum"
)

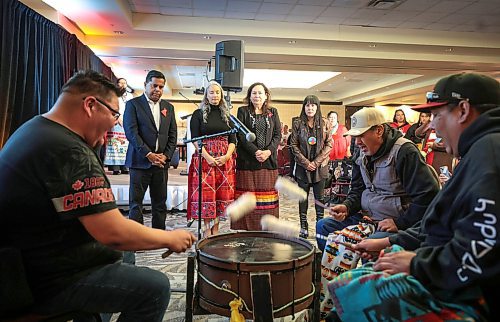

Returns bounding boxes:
[0,71,195,322]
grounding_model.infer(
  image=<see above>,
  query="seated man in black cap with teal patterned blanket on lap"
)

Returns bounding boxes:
[330,73,500,321]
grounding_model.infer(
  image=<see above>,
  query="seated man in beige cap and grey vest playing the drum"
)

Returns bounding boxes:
[316,108,439,251]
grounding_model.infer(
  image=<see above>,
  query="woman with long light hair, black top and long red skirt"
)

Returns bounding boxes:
[187,81,236,237]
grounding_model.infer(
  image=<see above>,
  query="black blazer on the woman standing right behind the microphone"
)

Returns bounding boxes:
[236,106,281,170]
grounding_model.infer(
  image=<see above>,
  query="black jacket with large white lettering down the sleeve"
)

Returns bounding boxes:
[390,108,500,319]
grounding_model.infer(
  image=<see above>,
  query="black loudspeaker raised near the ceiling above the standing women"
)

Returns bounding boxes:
[215,40,245,92]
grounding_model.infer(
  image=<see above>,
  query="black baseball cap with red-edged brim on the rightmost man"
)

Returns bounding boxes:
[411,73,500,112]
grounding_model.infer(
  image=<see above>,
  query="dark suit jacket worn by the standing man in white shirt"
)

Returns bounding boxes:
[123,95,177,169]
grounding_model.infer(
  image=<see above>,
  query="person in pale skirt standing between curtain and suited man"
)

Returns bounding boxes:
[104,78,133,174]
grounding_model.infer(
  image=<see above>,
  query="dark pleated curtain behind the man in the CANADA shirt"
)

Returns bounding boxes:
[0,0,115,148]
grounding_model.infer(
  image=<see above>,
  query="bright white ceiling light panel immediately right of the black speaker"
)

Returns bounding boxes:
[243,69,341,89]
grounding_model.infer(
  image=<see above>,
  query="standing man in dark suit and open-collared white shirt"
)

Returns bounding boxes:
[123,70,177,229]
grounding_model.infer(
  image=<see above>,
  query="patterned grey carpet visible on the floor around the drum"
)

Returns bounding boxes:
[110,167,316,322]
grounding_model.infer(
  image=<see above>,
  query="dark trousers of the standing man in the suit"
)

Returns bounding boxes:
[128,166,168,229]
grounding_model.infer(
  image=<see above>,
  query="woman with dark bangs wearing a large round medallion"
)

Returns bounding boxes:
[290,95,332,238]
